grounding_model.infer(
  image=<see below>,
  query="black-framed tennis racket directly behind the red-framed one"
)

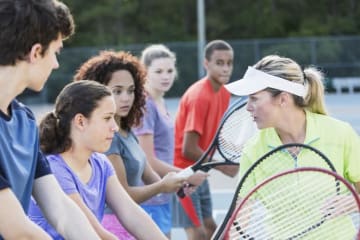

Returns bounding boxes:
[212,143,336,240]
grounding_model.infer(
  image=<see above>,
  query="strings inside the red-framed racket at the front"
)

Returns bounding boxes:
[230,173,359,239]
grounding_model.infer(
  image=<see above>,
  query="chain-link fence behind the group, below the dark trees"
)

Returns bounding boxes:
[21,36,360,102]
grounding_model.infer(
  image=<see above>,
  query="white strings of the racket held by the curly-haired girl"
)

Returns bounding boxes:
[217,107,256,162]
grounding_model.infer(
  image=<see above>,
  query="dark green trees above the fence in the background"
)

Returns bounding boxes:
[60,0,360,46]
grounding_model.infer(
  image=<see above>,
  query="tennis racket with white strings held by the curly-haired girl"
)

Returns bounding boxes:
[178,98,257,197]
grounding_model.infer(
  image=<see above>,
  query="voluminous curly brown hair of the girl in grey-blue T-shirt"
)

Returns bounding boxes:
[74,51,146,130]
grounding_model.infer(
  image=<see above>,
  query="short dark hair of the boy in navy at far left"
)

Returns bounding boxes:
[0,0,74,65]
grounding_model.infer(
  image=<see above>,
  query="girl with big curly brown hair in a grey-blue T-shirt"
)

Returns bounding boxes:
[74,51,185,239]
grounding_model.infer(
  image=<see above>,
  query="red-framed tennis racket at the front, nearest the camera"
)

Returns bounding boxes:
[224,168,360,240]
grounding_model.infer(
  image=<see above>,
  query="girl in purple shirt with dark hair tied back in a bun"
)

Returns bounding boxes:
[28,81,166,239]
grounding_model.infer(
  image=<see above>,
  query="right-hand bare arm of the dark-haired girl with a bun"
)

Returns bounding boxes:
[106,176,167,240]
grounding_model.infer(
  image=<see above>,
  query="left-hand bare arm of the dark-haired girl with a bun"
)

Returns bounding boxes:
[68,193,118,240]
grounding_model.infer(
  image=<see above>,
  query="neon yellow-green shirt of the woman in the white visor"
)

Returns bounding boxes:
[240,111,360,187]
